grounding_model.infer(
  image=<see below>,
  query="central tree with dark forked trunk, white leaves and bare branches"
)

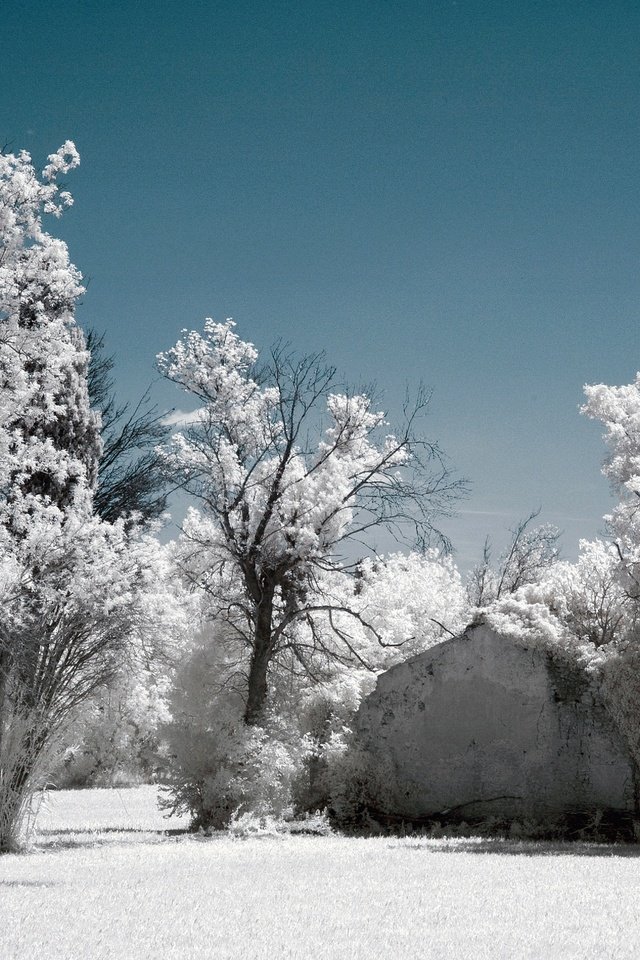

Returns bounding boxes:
[158,320,461,725]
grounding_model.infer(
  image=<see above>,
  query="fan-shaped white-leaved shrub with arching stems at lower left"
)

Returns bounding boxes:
[0,532,149,852]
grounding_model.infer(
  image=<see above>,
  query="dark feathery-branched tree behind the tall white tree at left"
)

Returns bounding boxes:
[87,330,170,522]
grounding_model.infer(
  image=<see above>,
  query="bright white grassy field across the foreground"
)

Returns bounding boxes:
[0,787,640,960]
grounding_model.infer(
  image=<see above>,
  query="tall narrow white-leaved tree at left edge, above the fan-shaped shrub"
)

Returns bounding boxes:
[0,141,100,516]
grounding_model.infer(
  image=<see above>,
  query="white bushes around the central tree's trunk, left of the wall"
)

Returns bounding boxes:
[163,551,467,826]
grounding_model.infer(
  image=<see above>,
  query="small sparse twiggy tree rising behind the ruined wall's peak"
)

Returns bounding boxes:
[467,510,560,607]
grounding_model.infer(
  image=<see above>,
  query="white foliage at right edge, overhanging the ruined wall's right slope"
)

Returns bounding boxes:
[462,374,640,776]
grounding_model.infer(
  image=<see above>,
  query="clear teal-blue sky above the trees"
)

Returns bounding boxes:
[0,0,640,568]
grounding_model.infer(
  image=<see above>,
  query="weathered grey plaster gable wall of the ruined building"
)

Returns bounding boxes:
[357,626,635,819]
